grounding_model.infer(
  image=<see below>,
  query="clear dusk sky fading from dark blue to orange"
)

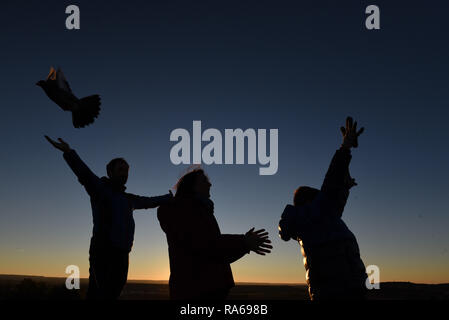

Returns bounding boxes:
[0,0,449,283]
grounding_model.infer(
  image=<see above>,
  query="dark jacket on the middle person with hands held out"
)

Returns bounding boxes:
[157,197,249,299]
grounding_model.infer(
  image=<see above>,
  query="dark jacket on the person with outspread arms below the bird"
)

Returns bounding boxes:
[63,150,172,252]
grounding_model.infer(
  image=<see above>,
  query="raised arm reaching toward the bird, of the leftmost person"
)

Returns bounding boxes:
[45,136,105,197]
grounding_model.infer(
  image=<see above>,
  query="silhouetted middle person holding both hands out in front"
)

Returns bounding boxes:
[157,169,272,300]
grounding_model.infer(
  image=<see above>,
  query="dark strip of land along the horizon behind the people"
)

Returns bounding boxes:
[0,275,449,300]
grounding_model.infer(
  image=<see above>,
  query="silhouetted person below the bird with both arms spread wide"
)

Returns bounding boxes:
[45,136,173,299]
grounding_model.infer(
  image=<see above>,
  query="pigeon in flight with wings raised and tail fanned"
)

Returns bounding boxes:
[36,67,101,128]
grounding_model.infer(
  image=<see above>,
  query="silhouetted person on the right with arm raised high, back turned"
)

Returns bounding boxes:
[279,117,367,300]
